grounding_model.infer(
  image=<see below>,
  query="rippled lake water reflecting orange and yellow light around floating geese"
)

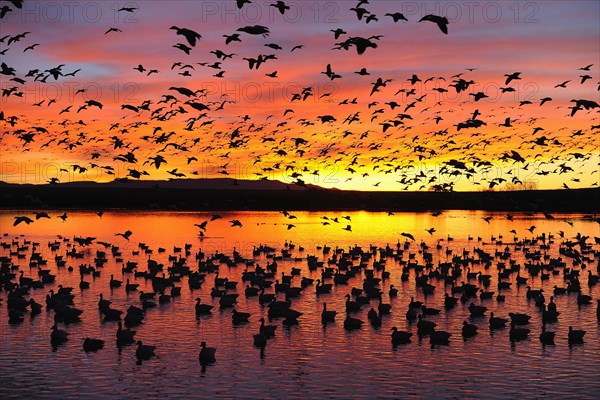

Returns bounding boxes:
[0,210,600,399]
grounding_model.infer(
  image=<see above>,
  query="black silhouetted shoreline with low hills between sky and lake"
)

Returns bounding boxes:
[0,180,600,213]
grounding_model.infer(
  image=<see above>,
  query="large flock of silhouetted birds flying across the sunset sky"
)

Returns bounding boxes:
[0,0,600,191]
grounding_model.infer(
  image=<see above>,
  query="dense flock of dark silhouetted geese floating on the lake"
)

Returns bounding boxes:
[0,212,600,366]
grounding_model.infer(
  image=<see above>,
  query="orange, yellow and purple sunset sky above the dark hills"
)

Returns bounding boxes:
[0,0,600,190]
